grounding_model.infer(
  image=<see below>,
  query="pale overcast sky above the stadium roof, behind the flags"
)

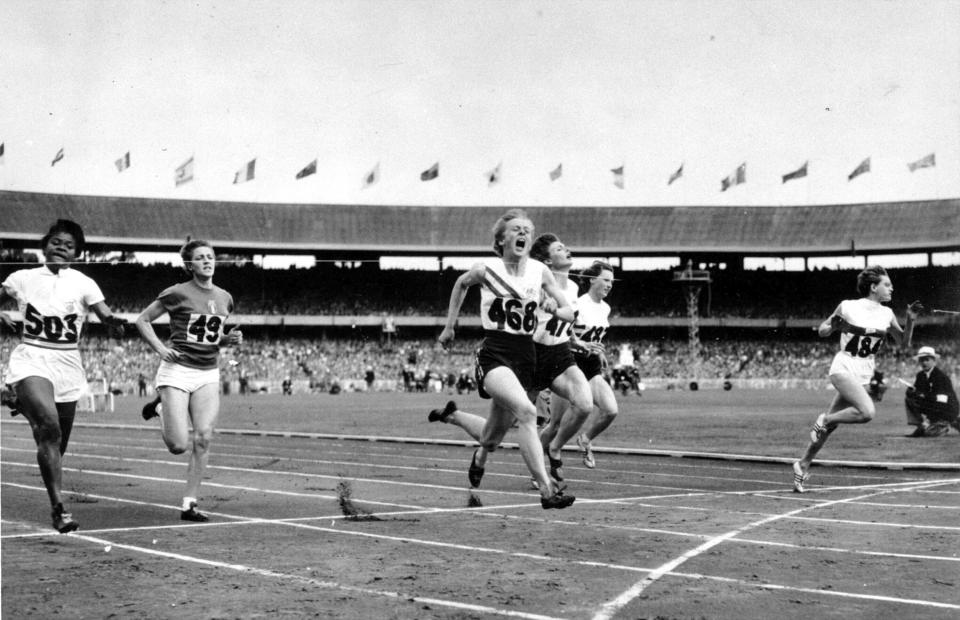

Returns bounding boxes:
[0,0,960,205]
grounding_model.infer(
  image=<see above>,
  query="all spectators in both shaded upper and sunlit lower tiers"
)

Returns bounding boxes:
[0,262,960,392]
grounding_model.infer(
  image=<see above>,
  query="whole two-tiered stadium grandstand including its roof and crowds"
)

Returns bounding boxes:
[0,191,960,392]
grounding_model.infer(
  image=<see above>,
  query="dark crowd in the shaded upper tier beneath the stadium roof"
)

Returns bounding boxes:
[0,262,960,319]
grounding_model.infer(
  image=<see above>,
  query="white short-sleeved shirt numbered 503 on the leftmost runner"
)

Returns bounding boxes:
[3,266,104,349]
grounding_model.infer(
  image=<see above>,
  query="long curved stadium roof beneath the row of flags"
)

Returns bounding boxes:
[0,191,960,259]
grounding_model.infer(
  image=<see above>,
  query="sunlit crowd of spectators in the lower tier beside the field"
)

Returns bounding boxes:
[0,336,960,394]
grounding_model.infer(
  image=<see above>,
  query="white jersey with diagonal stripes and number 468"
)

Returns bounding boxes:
[480,258,547,336]
